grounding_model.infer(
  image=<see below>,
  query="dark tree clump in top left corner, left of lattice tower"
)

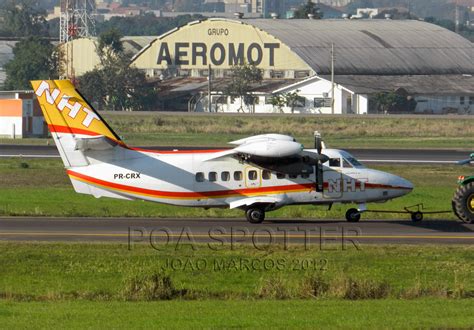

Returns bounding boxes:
[0,0,48,37]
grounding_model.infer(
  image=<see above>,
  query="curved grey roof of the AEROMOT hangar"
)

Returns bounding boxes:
[241,19,474,75]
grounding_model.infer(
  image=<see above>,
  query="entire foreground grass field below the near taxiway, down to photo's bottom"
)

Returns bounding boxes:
[0,242,474,329]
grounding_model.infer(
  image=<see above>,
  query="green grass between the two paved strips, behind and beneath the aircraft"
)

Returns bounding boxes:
[0,158,463,219]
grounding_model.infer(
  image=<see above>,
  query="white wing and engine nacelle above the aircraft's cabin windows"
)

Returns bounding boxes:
[204,134,318,174]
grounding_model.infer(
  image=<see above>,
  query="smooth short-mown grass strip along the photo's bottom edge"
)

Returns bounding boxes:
[0,299,474,329]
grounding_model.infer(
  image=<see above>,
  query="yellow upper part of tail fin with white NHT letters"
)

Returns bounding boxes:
[31,80,122,144]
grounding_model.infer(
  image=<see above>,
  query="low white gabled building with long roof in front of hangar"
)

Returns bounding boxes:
[193,74,474,115]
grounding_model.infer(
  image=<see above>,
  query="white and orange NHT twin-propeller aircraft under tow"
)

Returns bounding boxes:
[32,80,413,223]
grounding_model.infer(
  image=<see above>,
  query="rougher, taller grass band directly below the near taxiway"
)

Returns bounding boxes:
[0,242,474,301]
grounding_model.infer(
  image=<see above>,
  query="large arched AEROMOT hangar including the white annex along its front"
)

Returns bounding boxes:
[131,18,474,114]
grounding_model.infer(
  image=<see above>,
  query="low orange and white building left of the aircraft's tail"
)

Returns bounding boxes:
[0,91,48,139]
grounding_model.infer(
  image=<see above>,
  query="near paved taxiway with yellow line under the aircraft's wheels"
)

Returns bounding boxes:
[0,217,474,247]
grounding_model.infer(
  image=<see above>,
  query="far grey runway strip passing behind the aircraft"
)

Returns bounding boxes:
[0,144,469,164]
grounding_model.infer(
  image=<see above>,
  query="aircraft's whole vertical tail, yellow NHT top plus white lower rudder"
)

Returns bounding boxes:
[31,80,124,167]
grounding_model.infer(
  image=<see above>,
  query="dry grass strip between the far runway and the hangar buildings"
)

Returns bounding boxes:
[0,112,474,149]
